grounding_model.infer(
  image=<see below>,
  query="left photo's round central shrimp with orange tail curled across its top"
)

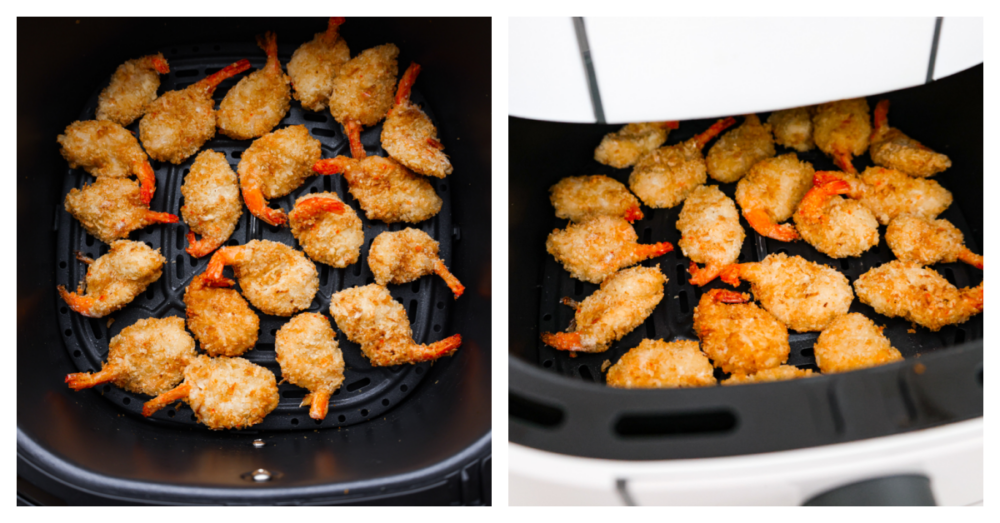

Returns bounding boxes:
[288,192,365,269]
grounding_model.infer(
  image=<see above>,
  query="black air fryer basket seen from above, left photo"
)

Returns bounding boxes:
[17,18,491,504]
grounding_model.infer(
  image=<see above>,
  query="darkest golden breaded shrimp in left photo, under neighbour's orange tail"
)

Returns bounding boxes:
[184,274,260,356]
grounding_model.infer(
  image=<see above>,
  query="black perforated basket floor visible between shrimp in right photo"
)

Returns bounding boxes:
[538,113,983,383]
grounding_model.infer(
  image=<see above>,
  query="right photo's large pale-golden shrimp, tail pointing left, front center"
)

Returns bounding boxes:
[722,253,854,332]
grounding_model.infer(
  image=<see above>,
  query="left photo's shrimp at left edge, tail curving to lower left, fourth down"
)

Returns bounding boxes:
[58,240,167,318]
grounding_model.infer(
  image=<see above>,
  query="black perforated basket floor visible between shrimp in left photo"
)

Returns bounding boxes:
[52,43,458,432]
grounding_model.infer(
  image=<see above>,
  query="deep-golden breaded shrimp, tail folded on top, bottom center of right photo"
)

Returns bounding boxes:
[694,289,791,374]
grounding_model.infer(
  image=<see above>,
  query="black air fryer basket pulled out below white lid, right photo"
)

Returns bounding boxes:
[509,65,984,460]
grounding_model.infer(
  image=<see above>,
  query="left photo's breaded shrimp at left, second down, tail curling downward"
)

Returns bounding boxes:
[56,120,156,205]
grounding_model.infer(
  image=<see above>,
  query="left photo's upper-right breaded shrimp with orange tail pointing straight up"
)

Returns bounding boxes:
[378,63,452,178]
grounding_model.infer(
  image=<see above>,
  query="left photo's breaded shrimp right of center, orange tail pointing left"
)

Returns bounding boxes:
[312,156,443,223]
